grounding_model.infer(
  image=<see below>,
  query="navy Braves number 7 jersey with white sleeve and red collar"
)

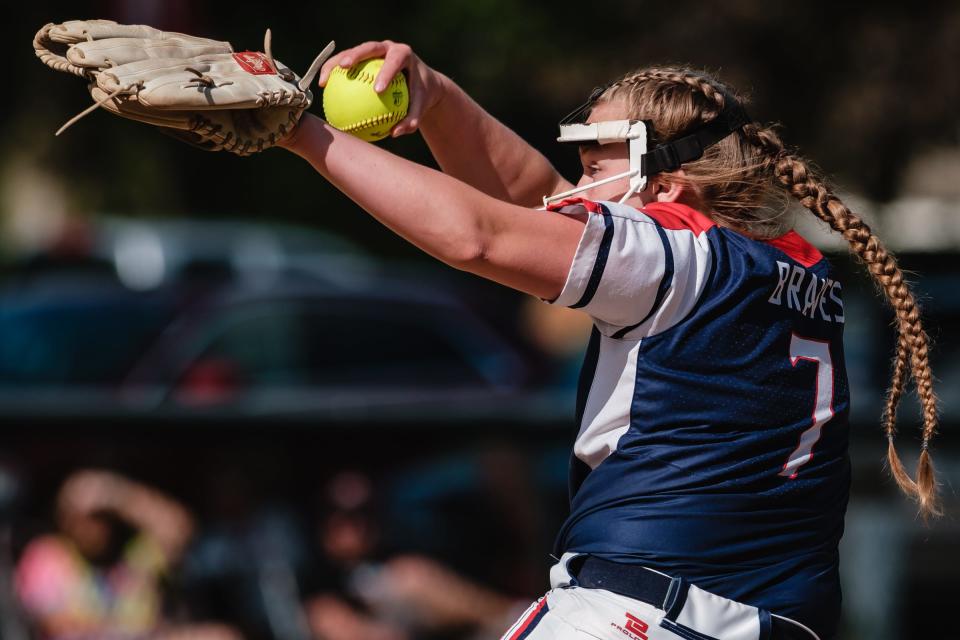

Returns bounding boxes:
[551,200,850,638]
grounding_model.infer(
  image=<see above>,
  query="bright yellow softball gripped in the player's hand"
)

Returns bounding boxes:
[323,58,410,142]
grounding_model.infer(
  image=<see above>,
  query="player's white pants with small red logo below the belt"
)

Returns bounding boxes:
[502,553,817,640]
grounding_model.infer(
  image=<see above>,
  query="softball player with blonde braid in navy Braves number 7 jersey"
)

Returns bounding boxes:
[283,41,938,640]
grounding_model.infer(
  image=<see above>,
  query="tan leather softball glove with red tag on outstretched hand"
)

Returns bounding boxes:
[33,20,334,156]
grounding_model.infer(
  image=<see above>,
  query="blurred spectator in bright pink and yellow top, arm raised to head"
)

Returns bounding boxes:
[16,470,238,640]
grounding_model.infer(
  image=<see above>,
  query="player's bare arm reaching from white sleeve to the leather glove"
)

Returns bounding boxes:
[280,114,585,299]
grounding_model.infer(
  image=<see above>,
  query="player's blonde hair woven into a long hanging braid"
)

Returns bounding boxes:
[598,67,941,519]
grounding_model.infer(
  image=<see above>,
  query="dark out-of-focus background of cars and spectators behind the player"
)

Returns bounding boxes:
[0,0,960,640]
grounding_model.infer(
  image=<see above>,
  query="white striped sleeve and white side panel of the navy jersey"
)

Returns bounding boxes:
[553,202,711,469]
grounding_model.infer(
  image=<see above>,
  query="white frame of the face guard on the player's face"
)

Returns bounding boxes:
[543,120,647,209]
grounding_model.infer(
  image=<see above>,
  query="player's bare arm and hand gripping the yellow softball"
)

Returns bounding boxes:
[319,40,572,207]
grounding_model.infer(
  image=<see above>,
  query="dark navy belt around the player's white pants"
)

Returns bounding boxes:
[567,555,686,611]
